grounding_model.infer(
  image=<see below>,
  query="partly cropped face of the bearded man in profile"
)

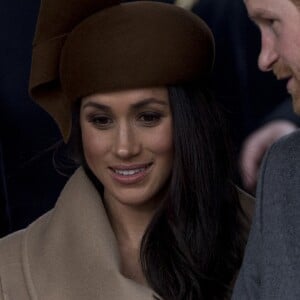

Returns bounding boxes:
[244,0,300,113]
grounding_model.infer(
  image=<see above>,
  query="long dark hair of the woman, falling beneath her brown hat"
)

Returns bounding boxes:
[73,86,246,300]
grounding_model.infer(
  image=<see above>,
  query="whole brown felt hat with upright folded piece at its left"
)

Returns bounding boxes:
[29,0,214,141]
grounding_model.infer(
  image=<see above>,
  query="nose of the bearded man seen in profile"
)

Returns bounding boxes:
[258,34,279,72]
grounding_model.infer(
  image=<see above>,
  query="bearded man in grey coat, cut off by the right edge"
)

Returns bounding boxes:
[233,0,300,300]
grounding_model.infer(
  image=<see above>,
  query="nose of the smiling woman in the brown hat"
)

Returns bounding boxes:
[114,124,141,159]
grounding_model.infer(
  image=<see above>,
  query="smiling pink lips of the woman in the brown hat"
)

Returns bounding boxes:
[109,163,152,184]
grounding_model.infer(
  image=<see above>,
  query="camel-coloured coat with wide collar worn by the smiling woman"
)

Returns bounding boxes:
[0,168,253,300]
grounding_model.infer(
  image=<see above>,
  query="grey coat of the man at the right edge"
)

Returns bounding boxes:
[232,131,300,300]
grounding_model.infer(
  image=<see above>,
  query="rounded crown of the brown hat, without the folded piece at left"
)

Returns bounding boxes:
[60,1,214,100]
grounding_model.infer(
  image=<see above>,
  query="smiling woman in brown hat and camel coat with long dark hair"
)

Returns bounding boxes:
[0,0,253,300]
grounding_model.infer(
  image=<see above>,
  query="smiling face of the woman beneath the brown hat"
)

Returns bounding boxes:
[80,88,173,206]
